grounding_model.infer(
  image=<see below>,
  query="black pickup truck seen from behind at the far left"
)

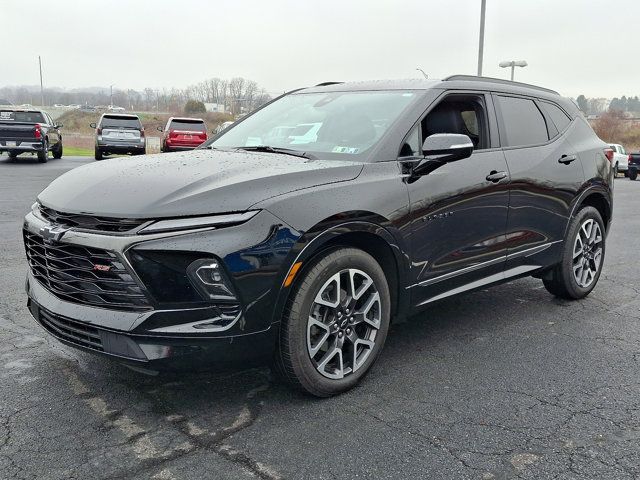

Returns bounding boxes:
[0,109,62,163]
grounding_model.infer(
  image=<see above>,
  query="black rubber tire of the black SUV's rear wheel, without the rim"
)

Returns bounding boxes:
[542,206,606,300]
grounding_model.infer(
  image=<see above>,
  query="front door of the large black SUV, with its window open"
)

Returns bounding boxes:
[400,92,509,306]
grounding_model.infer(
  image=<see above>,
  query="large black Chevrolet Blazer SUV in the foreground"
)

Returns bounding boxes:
[24,76,613,396]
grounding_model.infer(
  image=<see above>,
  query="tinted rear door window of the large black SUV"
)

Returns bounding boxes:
[497,96,549,147]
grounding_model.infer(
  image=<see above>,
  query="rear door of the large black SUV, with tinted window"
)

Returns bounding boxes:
[494,94,584,273]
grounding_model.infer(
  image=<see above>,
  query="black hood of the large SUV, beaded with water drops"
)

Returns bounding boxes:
[38,149,363,218]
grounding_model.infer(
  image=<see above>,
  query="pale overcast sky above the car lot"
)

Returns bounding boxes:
[0,0,640,97]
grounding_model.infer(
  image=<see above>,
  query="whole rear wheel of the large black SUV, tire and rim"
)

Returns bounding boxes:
[542,207,605,300]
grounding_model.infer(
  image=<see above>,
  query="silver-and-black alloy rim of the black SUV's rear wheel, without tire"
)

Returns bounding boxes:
[573,218,603,288]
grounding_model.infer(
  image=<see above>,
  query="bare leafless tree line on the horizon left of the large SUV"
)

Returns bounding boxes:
[0,77,271,115]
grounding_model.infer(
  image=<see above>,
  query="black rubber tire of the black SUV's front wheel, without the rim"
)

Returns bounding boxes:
[275,248,391,397]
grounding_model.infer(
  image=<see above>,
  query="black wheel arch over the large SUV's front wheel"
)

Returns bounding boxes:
[272,212,409,323]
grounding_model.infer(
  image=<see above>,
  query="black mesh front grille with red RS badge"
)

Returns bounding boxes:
[24,230,151,310]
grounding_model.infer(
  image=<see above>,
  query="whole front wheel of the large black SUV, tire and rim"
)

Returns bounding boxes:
[276,248,391,397]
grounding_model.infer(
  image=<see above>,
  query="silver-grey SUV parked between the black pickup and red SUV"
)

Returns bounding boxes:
[90,113,147,160]
